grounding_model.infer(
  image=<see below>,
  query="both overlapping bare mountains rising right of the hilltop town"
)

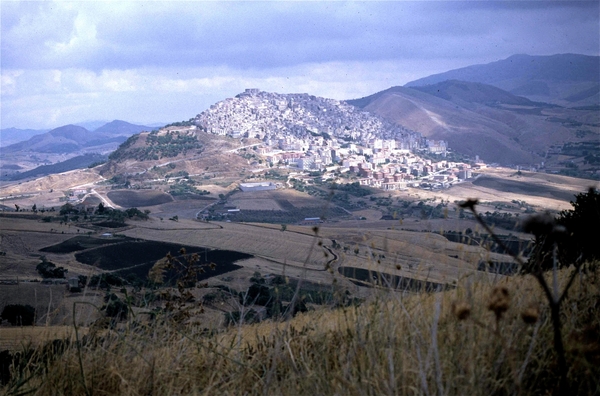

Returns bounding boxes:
[348,54,600,165]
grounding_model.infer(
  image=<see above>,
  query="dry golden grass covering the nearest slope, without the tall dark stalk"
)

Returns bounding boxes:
[0,265,600,395]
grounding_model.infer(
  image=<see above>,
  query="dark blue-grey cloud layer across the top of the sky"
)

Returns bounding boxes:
[2,1,598,70]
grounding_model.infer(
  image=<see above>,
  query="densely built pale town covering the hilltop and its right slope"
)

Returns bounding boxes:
[195,89,486,191]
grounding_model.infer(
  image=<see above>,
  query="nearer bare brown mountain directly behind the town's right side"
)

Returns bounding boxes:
[348,80,598,164]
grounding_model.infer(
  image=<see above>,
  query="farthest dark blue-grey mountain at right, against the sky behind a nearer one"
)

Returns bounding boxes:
[405,54,600,107]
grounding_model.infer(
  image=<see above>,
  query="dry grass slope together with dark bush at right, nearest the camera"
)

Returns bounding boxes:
[0,190,600,395]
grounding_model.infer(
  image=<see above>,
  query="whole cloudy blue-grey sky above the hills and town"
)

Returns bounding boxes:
[0,0,600,128]
